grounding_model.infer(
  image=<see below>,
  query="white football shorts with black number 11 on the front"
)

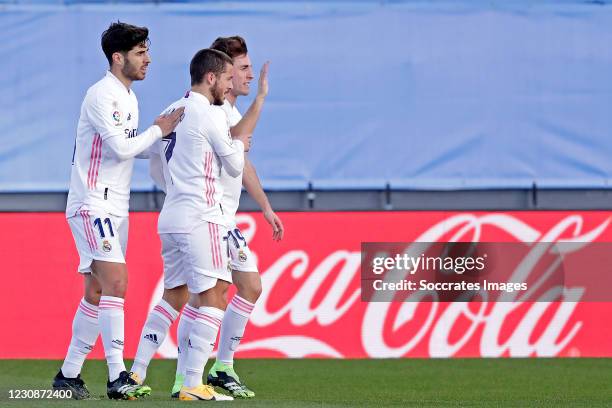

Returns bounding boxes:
[68,210,129,273]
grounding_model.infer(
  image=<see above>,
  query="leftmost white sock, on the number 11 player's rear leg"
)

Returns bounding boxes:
[62,298,100,378]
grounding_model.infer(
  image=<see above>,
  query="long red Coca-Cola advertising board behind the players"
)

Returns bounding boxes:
[0,211,612,358]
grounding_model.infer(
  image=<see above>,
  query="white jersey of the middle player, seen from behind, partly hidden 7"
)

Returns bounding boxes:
[156,91,244,234]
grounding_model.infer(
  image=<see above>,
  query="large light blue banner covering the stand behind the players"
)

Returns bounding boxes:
[0,1,612,191]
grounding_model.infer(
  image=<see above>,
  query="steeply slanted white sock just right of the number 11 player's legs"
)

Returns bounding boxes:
[132,299,178,381]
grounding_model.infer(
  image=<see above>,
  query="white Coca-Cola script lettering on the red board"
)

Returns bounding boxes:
[150,213,610,358]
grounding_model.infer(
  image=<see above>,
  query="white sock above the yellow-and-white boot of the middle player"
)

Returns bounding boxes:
[184,306,224,387]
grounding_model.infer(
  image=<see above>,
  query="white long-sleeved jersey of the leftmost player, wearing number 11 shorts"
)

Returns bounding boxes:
[66,71,161,218]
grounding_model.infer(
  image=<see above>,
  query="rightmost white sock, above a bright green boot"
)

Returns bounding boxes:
[217,295,255,365]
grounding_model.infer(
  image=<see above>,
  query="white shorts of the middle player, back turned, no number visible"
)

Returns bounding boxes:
[159,221,232,293]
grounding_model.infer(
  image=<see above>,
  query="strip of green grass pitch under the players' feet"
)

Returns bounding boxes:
[0,359,612,408]
